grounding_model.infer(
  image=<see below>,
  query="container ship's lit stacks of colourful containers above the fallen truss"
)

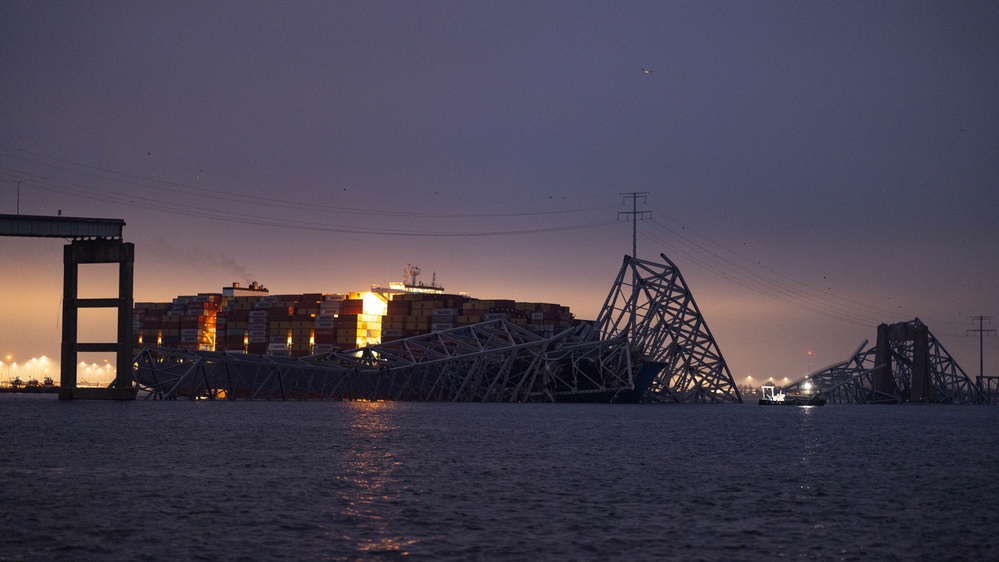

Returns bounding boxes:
[133,265,575,357]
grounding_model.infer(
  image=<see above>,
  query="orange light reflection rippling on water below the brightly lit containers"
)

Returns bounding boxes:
[334,402,414,555]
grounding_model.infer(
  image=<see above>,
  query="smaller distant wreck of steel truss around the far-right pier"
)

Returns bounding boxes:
[785,318,988,404]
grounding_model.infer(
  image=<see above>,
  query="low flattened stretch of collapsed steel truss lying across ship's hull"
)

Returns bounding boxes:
[135,320,634,402]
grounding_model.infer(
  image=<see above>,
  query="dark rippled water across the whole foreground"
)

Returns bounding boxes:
[0,395,999,561]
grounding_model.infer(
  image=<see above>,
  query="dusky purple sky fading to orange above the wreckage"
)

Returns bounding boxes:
[0,0,999,384]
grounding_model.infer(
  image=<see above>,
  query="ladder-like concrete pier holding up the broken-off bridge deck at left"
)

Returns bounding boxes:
[59,238,135,400]
